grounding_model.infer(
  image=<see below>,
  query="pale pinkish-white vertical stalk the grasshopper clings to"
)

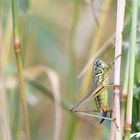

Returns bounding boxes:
[110,0,125,140]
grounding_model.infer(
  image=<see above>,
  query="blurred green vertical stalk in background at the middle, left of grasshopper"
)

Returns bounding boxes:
[66,0,79,140]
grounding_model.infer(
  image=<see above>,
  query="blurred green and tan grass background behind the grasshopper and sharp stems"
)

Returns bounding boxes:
[0,0,140,140]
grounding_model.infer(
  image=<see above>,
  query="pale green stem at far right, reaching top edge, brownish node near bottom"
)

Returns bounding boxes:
[125,0,138,140]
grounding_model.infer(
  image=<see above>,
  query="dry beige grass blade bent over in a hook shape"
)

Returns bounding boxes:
[26,66,62,140]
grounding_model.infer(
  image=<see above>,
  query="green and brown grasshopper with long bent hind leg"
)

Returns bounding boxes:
[71,55,120,126]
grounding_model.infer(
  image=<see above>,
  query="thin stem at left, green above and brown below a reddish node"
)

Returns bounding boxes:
[12,0,30,140]
